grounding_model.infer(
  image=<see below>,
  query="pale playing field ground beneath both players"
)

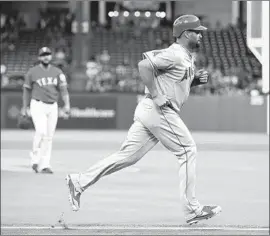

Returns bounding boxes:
[1,130,269,235]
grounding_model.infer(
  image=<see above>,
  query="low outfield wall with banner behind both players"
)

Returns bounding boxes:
[1,91,267,132]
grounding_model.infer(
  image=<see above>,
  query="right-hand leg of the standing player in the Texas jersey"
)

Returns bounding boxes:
[40,103,58,174]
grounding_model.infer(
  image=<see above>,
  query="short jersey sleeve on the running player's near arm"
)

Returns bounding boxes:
[143,50,175,70]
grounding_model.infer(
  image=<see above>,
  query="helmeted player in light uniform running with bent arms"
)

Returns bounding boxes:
[66,15,221,224]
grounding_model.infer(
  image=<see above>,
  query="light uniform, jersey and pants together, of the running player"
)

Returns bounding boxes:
[71,44,202,219]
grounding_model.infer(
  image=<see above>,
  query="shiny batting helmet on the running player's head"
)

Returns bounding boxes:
[173,15,207,38]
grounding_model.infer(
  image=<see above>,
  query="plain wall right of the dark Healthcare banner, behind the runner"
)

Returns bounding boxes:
[117,95,267,133]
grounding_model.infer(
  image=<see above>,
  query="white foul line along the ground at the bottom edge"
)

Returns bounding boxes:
[1,226,269,231]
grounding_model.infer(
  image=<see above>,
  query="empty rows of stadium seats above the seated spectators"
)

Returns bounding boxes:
[1,27,261,77]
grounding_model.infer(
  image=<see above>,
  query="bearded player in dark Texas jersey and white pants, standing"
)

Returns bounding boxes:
[22,47,70,174]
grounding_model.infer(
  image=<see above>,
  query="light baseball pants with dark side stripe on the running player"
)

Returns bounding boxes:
[71,98,202,219]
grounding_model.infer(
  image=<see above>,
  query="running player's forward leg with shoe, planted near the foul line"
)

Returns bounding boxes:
[156,108,221,224]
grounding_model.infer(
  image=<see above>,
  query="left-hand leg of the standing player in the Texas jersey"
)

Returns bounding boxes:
[30,99,47,172]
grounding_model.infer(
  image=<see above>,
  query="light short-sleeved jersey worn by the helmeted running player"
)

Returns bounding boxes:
[143,43,194,112]
